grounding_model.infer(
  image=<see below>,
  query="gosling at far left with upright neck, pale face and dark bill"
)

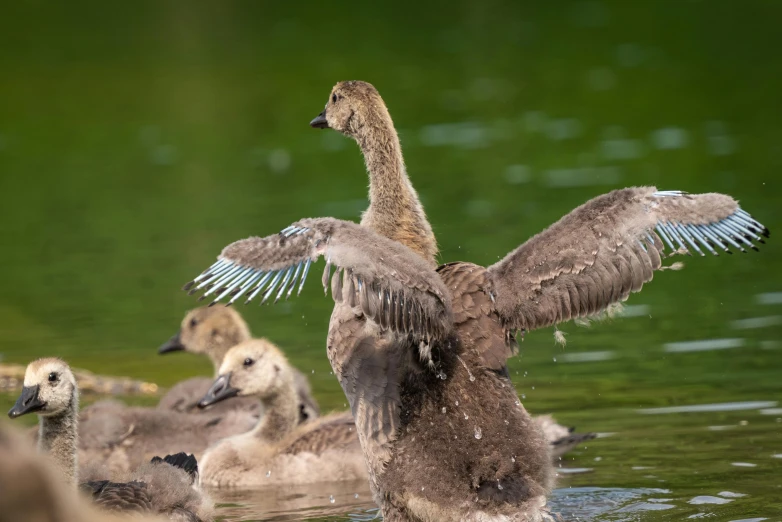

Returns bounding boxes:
[8,358,213,522]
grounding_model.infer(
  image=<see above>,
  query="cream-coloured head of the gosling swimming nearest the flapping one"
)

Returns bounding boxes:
[198,339,294,408]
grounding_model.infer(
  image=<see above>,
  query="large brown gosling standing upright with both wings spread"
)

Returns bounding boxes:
[186,82,768,521]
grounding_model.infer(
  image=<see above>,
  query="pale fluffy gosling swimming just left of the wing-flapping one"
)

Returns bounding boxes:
[199,339,368,487]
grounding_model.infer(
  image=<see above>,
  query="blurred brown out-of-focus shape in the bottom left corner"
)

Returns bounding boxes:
[0,422,167,522]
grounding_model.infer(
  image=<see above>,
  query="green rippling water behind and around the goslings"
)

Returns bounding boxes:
[0,0,782,521]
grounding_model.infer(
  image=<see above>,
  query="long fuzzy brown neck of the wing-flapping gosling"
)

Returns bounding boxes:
[356,107,437,267]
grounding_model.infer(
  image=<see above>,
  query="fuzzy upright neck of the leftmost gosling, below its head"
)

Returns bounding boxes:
[38,389,79,487]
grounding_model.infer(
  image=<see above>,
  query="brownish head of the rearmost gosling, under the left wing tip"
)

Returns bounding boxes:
[158,305,250,366]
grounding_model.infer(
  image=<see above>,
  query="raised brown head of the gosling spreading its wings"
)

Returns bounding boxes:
[310,81,390,139]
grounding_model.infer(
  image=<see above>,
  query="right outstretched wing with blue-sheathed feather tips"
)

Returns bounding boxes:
[489,187,769,330]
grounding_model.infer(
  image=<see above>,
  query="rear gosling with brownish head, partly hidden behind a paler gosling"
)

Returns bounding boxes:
[158,306,320,422]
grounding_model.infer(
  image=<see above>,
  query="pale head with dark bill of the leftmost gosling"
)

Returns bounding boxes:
[8,357,78,419]
